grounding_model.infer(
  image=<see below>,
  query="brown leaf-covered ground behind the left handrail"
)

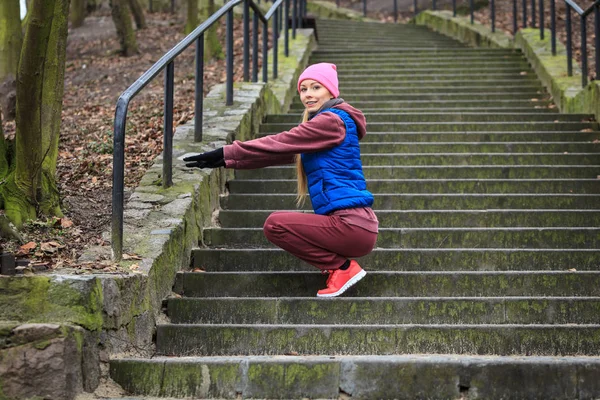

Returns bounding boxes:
[2,7,270,273]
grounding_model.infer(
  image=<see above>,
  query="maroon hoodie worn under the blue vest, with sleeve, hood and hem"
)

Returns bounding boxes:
[223,103,378,232]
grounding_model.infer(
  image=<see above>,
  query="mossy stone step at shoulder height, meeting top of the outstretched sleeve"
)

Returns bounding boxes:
[259,122,598,133]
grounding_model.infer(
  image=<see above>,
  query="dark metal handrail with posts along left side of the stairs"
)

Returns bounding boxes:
[111,0,306,262]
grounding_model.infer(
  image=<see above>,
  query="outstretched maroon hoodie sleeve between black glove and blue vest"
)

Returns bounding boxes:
[223,112,346,169]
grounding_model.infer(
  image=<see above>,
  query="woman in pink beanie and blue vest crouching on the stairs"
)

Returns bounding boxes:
[184,63,379,297]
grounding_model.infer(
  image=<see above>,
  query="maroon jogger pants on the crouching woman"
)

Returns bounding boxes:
[263,211,377,270]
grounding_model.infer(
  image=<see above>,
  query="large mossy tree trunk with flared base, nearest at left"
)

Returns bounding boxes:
[2,0,69,227]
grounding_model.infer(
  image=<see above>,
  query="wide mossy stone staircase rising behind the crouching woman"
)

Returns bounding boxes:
[111,21,600,399]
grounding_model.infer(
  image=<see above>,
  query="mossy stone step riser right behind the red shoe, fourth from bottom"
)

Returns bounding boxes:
[173,266,600,301]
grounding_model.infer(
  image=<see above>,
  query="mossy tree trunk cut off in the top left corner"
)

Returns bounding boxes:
[0,0,23,84]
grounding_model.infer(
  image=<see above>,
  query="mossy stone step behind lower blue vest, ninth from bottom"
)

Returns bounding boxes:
[228,179,600,195]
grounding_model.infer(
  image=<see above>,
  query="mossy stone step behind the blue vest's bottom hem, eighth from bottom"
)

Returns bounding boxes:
[221,193,600,210]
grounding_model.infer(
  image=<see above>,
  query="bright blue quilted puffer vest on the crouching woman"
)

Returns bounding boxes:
[302,108,373,215]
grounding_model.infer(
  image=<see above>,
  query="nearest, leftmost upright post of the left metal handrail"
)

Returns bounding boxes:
[111,98,128,262]
